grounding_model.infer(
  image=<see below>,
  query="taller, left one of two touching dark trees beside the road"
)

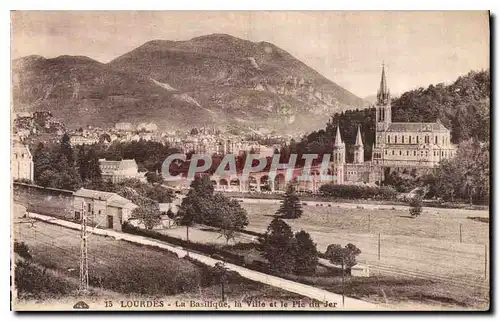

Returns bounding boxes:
[260,218,295,273]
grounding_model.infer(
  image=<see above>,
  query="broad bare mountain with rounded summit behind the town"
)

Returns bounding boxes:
[12,34,367,132]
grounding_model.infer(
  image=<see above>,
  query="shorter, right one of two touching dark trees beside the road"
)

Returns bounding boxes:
[294,230,318,275]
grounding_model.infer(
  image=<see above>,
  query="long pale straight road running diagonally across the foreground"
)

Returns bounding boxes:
[28,213,382,310]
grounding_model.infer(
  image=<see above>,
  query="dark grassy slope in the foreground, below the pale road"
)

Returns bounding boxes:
[15,221,308,302]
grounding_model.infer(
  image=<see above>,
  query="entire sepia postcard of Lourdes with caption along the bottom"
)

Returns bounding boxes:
[6,10,492,313]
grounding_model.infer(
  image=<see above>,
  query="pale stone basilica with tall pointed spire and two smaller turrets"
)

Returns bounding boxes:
[332,66,456,184]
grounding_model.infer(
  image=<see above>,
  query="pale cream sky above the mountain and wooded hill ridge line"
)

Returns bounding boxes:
[11,11,490,97]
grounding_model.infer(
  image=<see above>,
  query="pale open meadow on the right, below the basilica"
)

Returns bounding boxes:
[242,204,489,296]
